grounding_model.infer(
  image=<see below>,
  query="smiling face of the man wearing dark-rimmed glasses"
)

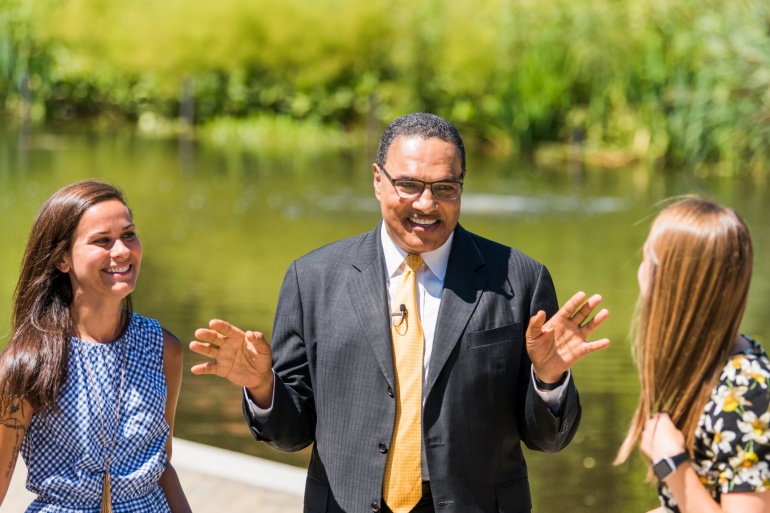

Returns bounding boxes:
[372,137,463,254]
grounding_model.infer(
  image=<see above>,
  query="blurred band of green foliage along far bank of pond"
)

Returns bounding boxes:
[0,0,770,175]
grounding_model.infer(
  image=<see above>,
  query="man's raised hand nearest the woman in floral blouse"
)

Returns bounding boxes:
[526,292,610,383]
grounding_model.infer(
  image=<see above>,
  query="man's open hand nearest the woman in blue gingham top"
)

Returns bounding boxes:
[190,319,274,409]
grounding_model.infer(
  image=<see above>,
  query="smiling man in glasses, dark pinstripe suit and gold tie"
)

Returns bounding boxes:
[190,113,609,513]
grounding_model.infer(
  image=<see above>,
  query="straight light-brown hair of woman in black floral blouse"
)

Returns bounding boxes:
[615,198,754,465]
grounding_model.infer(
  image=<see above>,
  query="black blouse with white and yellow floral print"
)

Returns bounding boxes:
[658,337,770,513]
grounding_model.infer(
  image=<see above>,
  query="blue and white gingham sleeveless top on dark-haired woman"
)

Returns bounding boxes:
[21,314,170,513]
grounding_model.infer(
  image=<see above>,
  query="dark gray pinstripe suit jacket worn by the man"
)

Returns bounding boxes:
[244,226,580,513]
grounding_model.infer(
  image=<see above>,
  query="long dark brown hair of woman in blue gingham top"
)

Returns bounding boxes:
[0,180,132,414]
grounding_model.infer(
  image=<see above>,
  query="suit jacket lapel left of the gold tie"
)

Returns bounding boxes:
[348,224,395,386]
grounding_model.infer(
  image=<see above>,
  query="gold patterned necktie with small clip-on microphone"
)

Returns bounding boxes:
[382,255,424,513]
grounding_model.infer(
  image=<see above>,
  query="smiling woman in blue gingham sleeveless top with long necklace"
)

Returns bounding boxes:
[0,181,190,513]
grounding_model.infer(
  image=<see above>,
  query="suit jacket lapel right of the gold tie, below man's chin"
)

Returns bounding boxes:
[425,225,487,397]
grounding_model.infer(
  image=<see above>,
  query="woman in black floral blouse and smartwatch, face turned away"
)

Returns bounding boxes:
[615,198,770,513]
